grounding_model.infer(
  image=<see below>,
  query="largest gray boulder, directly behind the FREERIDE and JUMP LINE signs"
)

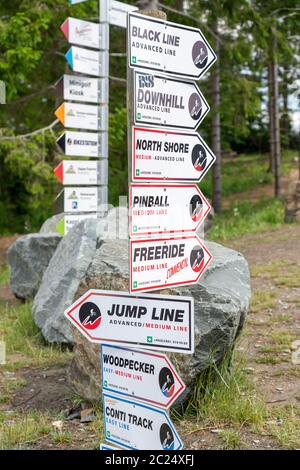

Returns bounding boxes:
[69,240,251,400]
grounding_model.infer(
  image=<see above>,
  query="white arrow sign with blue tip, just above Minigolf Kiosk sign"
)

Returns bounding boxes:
[66,46,106,77]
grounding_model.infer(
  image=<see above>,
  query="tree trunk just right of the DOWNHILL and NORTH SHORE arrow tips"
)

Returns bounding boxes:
[211,19,222,213]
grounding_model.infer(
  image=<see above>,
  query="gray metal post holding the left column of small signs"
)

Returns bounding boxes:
[98,0,110,217]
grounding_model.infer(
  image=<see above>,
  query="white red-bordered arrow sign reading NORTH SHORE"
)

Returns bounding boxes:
[132,127,216,182]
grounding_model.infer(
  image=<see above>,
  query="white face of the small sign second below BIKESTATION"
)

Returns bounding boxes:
[64,187,98,212]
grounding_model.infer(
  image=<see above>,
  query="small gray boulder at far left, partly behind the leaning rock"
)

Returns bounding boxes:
[7,233,61,300]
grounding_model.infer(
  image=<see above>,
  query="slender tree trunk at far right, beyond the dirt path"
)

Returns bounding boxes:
[271,32,281,197]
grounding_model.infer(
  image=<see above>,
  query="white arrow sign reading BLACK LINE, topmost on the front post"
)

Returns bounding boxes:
[128,13,217,79]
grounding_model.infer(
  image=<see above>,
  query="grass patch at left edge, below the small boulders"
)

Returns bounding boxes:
[0,303,72,370]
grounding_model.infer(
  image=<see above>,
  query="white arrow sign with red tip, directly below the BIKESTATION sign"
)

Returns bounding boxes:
[54,160,98,186]
